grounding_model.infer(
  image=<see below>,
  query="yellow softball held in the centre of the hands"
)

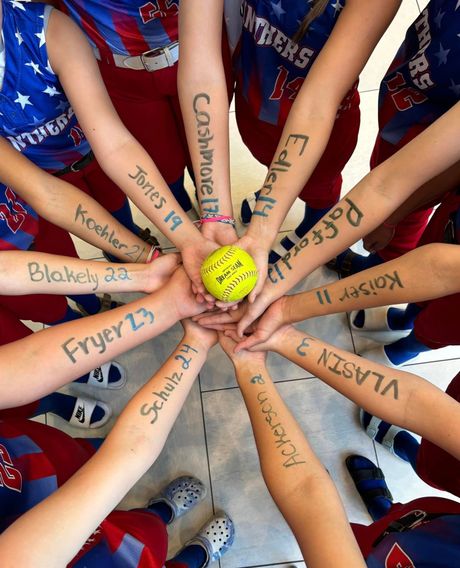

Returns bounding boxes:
[201,245,258,302]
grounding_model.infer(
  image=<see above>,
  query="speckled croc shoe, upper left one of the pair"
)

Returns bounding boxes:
[148,475,207,522]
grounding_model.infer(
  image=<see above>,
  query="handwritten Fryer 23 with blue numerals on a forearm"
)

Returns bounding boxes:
[61,308,155,363]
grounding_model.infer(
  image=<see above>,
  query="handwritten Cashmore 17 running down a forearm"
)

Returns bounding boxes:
[193,93,219,213]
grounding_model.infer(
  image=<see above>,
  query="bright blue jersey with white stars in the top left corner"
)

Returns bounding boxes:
[0,0,90,172]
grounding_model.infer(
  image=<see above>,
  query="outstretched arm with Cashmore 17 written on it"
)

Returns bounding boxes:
[177,0,236,245]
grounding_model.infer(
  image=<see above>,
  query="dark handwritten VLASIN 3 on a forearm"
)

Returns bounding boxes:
[296,337,399,400]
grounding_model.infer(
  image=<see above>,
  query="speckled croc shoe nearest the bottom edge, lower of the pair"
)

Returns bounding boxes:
[183,513,235,568]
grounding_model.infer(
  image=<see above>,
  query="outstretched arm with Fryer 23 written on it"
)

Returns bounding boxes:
[0,267,209,408]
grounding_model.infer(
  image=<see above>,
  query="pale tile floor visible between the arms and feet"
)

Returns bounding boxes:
[32,0,460,568]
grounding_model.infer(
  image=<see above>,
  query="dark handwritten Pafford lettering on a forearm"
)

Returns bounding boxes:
[268,197,364,284]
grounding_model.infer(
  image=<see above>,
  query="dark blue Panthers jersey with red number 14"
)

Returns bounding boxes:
[237,0,345,125]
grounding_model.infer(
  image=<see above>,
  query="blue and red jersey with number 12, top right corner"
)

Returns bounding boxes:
[379,0,460,147]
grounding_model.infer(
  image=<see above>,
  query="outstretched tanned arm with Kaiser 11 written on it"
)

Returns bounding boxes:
[225,243,460,350]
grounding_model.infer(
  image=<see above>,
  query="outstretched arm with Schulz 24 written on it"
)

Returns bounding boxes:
[0,323,217,568]
